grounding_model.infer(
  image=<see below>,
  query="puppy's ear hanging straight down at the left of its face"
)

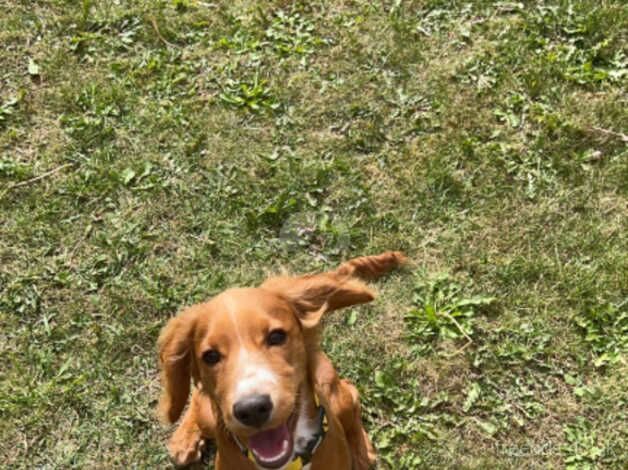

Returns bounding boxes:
[157,307,198,423]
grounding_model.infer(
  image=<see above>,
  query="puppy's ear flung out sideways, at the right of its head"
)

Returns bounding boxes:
[260,272,375,329]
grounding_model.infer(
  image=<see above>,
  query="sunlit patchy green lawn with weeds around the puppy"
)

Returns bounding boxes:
[0,0,628,470]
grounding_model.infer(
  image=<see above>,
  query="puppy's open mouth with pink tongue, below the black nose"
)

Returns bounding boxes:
[249,419,294,468]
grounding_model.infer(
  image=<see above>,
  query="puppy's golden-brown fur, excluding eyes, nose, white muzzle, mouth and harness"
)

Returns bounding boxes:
[158,252,405,470]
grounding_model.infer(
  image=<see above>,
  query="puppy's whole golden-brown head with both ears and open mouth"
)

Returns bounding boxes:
[158,272,374,468]
